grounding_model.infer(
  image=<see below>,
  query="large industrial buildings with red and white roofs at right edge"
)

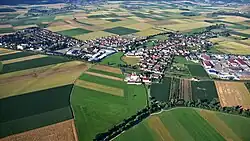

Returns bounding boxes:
[197,54,250,80]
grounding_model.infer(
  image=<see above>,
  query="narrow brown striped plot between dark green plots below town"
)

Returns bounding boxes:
[180,79,192,101]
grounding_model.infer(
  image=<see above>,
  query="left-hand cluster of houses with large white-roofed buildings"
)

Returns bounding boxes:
[0,27,141,62]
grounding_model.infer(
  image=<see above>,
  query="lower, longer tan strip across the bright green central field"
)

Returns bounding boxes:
[75,80,124,97]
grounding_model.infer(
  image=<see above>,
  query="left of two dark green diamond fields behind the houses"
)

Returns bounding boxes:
[57,28,92,37]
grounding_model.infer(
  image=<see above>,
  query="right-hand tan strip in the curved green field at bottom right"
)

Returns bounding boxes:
[200,110,241,141]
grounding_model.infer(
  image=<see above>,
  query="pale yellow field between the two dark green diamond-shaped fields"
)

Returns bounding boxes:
[74,31,115,40]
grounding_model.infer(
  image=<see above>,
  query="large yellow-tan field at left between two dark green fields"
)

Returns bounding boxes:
[0,61,88,98]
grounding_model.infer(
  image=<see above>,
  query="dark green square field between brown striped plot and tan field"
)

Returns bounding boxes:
[191,81,218,101]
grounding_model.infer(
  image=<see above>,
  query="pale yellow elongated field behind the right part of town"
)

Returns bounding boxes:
[161,22,211,31]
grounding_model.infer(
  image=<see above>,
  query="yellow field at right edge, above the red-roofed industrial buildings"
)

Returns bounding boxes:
[218,41,250,55]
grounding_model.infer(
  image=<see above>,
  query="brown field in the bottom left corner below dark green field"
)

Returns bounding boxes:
[0,120,78,141]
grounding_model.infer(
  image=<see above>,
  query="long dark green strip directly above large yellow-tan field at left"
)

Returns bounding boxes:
[0,56,69,74]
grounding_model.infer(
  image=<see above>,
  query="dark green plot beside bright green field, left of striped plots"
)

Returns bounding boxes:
[150,77,171,101]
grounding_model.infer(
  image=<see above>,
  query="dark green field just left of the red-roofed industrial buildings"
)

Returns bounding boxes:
[187,64,208,77]
